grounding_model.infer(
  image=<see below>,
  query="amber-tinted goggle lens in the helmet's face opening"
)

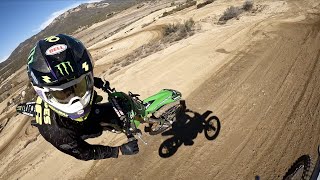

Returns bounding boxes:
[48,76,92,104]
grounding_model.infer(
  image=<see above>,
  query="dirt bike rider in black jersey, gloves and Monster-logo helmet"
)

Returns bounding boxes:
[22,34,139,160]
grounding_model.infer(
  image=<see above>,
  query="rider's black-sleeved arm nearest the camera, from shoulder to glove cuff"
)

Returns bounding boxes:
[38,125,119,161]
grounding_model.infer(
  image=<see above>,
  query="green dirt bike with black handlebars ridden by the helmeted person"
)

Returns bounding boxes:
[95,83,183,144]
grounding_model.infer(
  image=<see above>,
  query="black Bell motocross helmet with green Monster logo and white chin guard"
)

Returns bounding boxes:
[27,34,94,121]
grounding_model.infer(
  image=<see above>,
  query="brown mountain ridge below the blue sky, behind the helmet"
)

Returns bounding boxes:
[0,0,145,80]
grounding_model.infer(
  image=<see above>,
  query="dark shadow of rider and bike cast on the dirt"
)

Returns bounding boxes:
[159,104,221,158]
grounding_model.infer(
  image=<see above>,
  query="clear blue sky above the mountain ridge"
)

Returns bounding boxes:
[0,0,101,62]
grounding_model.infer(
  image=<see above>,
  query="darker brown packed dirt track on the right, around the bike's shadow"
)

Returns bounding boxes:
[87,3,320,179]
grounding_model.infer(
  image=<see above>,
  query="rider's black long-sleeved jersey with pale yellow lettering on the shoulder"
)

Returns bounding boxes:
[35,93,118,160]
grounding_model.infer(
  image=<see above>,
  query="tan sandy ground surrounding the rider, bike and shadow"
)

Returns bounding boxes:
[0,0,320,179]
